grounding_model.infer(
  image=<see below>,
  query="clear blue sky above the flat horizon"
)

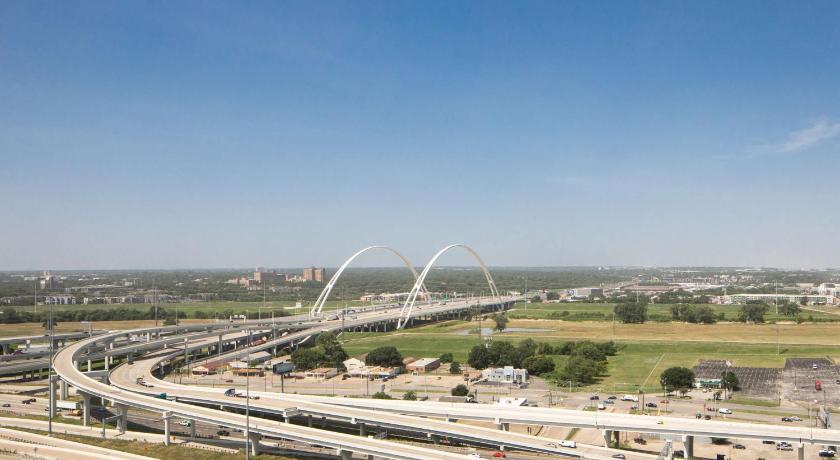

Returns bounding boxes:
[0,1,840,269]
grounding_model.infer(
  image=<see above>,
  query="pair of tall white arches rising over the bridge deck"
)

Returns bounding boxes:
[309,243,508,329]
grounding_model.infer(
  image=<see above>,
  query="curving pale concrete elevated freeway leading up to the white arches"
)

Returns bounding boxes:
[3,297,840,459]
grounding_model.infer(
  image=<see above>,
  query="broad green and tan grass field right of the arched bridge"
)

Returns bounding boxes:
[342,320,840,392]
